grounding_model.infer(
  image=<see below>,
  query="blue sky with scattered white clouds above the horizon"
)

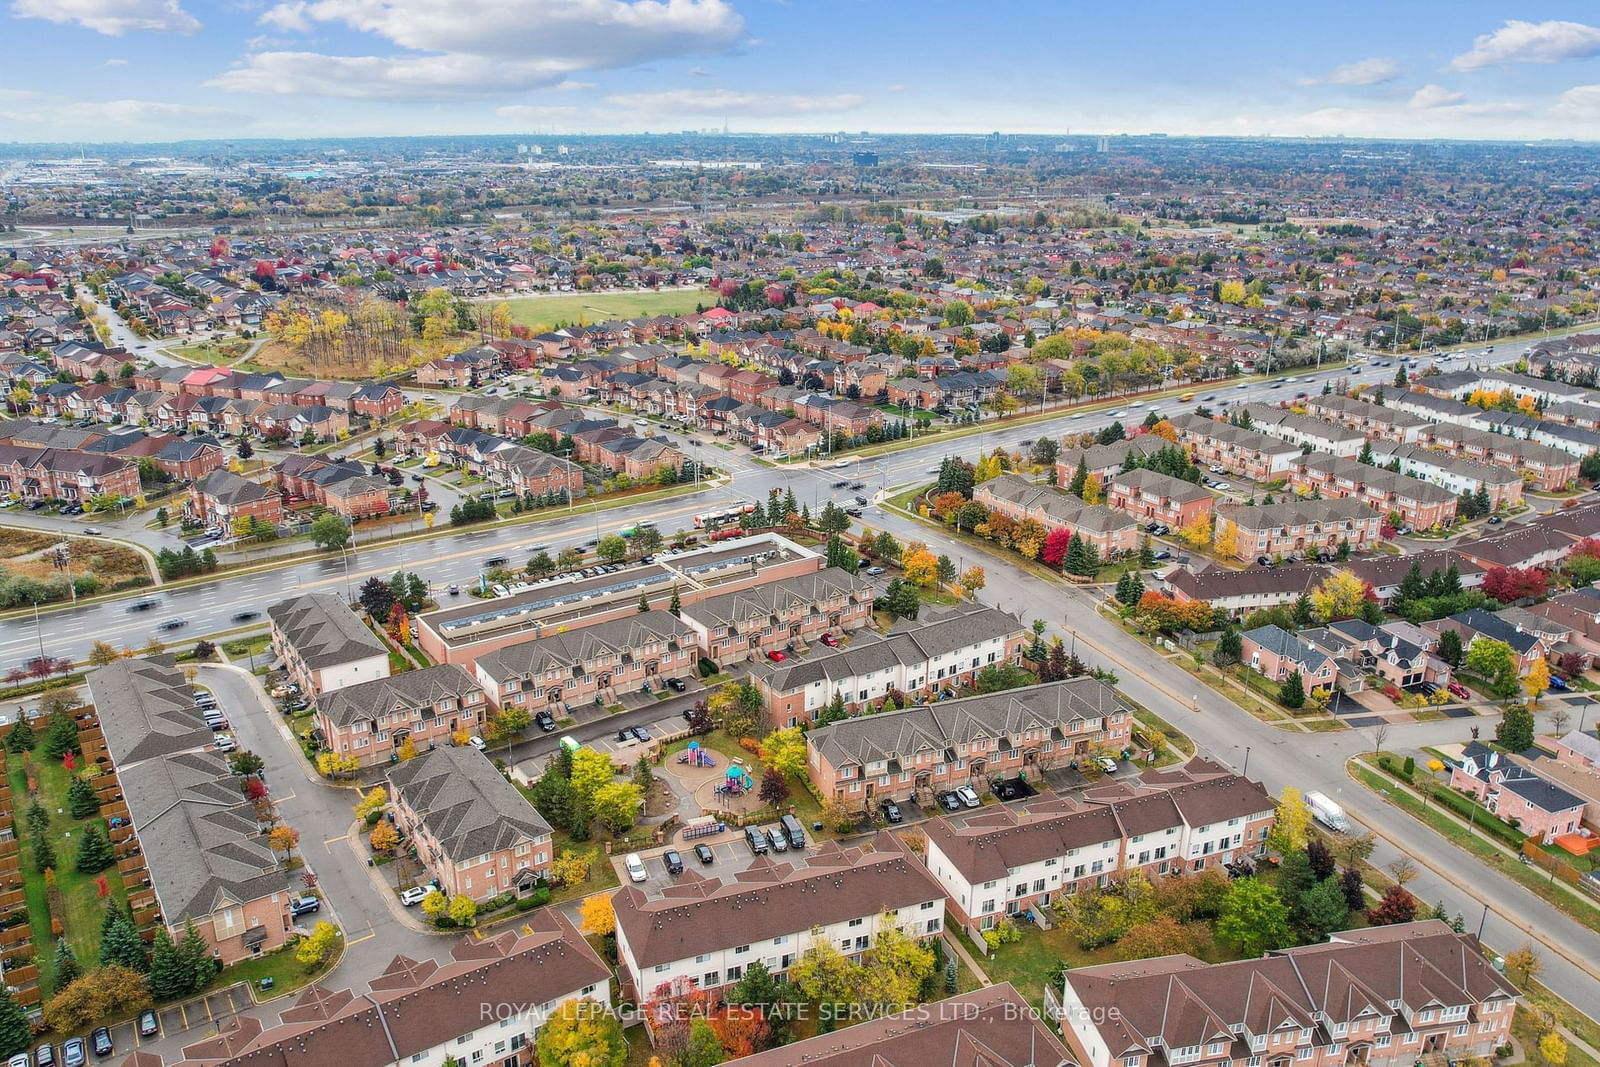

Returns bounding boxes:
[0,0,1600,142]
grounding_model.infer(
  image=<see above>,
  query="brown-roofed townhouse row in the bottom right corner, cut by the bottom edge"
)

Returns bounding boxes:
[1045,920,1517,1067]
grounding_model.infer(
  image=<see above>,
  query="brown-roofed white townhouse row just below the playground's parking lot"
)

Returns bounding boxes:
[611,833,944,1001]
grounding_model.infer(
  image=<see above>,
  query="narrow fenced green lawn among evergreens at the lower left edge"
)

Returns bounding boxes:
[6,748,128,987]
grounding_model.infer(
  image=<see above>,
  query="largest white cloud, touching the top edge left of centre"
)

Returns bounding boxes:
[225,0,744,99]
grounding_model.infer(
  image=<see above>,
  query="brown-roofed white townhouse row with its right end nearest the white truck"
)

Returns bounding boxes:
[925,758,1275,941]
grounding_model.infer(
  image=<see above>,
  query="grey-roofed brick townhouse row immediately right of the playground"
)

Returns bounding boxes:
[806,675,1133,808]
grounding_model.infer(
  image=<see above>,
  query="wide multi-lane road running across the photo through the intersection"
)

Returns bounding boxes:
[0,342,1526,665]
